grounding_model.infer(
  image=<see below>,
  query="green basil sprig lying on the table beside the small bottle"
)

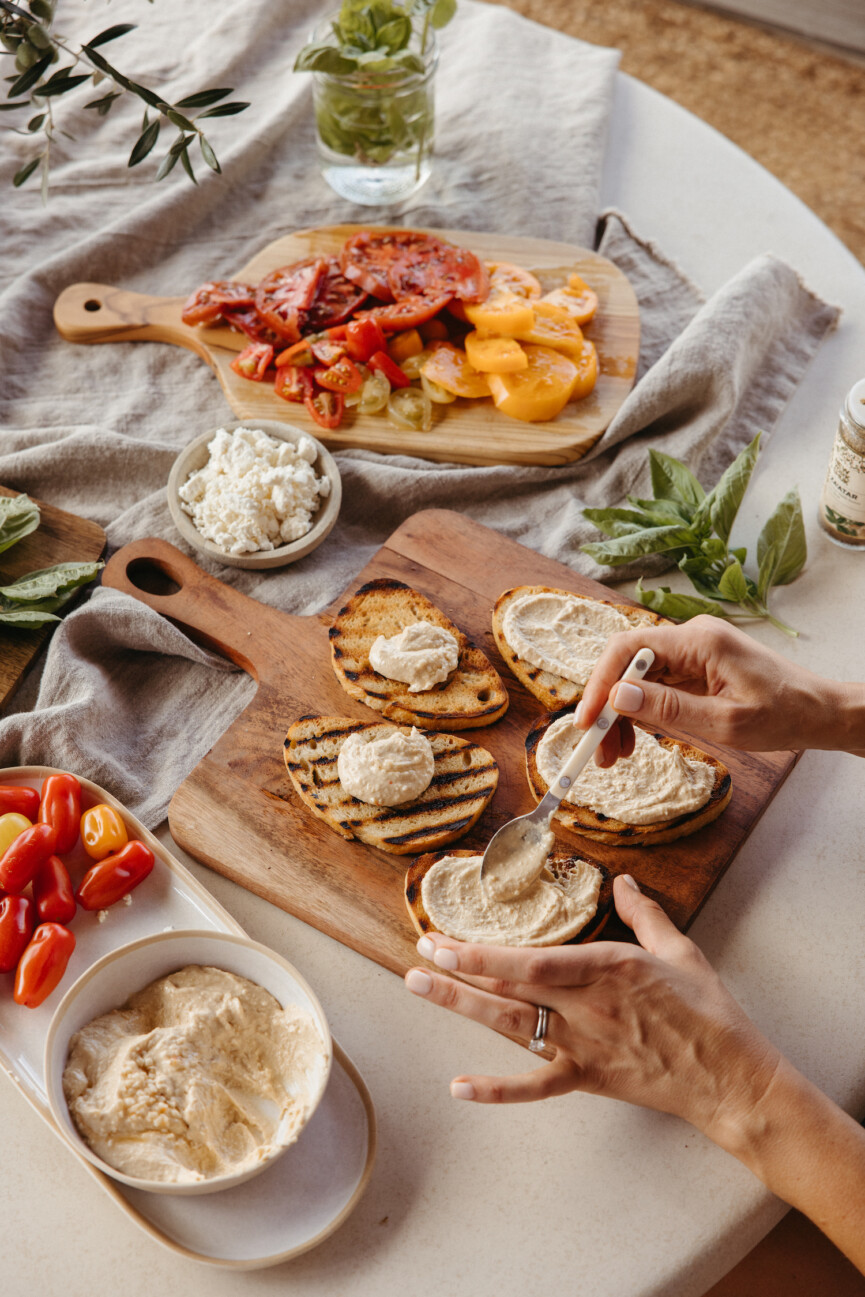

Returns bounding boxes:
[582,433,808,636]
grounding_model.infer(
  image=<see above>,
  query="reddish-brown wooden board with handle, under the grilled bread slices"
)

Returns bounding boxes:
[102,510,796,973]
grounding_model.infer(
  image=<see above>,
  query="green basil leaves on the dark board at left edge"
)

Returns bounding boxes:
[0,495,105,630]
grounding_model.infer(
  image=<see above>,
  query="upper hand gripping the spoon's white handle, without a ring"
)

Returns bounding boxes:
[577,616,865,765]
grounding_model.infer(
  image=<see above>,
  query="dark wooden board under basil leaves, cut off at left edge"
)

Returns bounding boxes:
[0,486,105,707]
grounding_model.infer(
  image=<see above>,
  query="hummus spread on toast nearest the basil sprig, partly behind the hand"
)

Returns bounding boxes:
[502,591,652,685]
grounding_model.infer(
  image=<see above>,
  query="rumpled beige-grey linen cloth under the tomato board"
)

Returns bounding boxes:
[0,0,838,825]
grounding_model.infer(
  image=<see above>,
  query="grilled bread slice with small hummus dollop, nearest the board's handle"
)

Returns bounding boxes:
[328,577,508,730]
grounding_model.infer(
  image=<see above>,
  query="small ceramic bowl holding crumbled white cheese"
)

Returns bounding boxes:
[169,419,342,568]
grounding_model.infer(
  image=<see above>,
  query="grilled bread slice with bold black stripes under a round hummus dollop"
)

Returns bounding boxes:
[284,716,498,855]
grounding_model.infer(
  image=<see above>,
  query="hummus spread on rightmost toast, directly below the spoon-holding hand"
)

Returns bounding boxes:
[537,716,715,825]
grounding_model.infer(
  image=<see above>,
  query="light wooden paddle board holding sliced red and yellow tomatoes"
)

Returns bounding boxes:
[54,226,639,464]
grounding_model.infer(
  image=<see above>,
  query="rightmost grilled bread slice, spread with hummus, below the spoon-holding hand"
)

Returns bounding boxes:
[525,708,733,847]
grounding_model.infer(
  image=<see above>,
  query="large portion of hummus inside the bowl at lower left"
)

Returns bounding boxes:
[64,965,327,1184]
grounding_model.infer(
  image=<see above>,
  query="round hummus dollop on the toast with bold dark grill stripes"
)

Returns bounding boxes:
[336,726,436,807]
